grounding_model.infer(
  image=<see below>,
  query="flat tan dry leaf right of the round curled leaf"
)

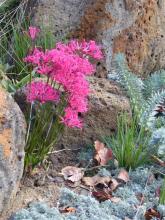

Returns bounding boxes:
[82,175,111,187]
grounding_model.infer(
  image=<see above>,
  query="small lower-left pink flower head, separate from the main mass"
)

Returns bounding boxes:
[26,81,60,103]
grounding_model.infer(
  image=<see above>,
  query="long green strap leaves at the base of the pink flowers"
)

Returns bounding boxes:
[24,99,65,171]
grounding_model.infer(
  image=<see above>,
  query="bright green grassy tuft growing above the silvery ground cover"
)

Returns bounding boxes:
[105,115,152,170]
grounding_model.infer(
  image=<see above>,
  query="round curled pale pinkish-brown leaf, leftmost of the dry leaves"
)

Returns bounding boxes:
[61,166,84,183]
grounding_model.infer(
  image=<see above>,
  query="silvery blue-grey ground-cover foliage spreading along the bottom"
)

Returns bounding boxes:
[9,167,165,220]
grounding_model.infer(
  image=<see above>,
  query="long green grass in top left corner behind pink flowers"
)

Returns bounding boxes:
[0,0,56,92]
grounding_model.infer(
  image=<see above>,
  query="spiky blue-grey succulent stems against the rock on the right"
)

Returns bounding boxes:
[114,53,165,130]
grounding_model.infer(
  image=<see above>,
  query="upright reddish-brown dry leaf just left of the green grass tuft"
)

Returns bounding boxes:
[94,141,113,166]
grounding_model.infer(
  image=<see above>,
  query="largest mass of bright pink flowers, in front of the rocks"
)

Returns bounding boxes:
[24,37,103,128]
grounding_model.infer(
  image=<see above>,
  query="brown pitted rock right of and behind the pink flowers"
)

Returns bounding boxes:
[57,77,131,147]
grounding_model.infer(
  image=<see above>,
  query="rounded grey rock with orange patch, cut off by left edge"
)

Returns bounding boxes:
[0,88,26,217]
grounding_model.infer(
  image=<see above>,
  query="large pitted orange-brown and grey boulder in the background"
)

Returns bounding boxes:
[34,0,165,76]
